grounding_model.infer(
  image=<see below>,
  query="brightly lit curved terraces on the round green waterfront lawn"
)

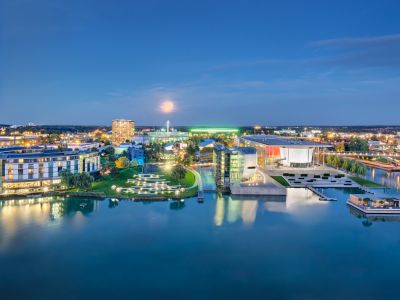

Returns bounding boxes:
[112,174,185,195]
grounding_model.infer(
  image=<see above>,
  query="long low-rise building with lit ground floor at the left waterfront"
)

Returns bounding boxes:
[0,147,100,195]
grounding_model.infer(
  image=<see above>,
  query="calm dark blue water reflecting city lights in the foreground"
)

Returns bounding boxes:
[0,189,400,299]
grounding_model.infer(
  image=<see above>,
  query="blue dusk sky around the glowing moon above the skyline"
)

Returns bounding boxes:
[0,0,400,125]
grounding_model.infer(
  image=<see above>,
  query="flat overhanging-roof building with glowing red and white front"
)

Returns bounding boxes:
[240,135,332,168]
